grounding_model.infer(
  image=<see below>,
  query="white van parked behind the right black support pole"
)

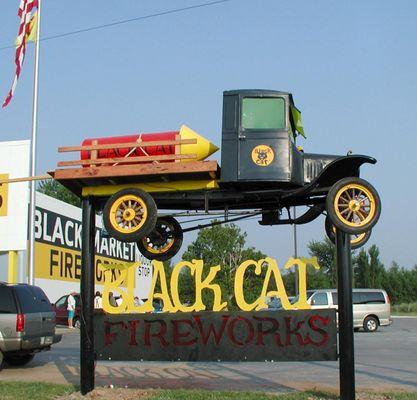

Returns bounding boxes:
[307,289,392,332]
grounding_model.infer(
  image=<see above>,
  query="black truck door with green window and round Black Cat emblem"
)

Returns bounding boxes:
[238,97,290,181]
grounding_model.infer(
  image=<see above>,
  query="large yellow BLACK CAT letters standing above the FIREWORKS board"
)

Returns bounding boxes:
[101,257,320,314]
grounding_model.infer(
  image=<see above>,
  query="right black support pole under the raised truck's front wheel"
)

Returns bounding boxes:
[336,229,355,400]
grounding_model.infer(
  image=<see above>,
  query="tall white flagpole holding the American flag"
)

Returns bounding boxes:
[28,0,41,285]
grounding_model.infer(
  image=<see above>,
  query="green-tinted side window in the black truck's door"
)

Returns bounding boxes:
[242,97,285,129]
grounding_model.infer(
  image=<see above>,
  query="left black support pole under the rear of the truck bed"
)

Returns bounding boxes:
[80,198,95,395]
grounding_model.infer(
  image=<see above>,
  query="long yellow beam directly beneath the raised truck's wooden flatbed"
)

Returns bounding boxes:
[82,179,219,197]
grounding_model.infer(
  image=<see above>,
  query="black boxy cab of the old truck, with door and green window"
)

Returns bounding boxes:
[220,90,304,187]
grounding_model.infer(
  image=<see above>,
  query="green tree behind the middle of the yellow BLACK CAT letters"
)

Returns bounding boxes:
[180,223,266,309]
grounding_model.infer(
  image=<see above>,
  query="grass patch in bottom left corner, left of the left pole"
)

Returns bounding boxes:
[0,382,77,400]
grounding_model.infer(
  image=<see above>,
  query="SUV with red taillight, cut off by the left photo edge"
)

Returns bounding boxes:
[0,282,62,368]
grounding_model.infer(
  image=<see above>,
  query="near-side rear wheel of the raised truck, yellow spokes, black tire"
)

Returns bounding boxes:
[103,189,157,242]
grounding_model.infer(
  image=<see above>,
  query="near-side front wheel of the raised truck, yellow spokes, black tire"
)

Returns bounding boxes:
[326,177,381,235]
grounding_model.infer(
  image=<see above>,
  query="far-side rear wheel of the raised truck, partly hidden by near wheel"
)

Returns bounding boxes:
[136,216,183,261]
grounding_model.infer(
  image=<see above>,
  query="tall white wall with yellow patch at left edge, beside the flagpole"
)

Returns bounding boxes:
[0,140,30,251]
